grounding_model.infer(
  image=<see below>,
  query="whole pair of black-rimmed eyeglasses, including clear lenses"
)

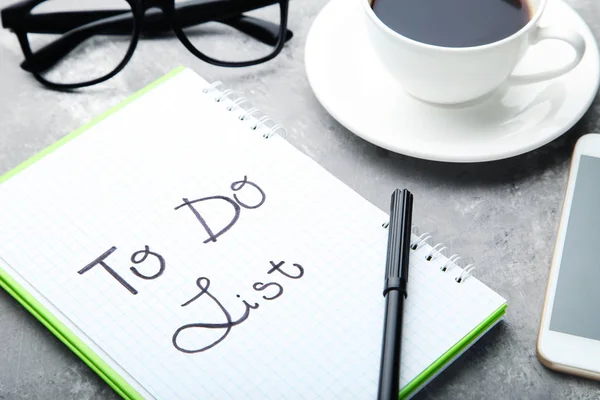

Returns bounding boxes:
[1,0,293,89]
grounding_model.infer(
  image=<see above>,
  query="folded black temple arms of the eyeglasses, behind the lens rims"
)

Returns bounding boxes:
[21,10,293,72]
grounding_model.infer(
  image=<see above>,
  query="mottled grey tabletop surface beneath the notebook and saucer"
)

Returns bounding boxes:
[0,0,600,400]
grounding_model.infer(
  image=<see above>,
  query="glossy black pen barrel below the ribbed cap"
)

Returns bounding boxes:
[377,290,404,400]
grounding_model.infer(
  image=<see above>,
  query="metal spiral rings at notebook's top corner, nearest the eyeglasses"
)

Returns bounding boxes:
[202,81,286,139]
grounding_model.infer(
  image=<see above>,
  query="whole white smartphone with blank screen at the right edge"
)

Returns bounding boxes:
[537,133,600,380]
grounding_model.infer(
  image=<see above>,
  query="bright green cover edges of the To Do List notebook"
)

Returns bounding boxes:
[0,67,507,400]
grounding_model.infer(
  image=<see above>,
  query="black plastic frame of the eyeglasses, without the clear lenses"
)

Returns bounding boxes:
[1,0,292,90]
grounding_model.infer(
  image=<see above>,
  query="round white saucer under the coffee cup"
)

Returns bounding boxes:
[305,0,600,162]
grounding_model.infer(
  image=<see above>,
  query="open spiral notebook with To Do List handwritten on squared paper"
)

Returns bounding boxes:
[0,68,506,400]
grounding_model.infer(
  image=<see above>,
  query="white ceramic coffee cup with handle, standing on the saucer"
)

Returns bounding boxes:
[355,0,585,104]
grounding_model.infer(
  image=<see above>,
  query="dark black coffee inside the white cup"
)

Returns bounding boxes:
[371,0,532,47]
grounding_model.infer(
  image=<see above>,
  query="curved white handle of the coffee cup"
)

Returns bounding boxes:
[508,27,585,85]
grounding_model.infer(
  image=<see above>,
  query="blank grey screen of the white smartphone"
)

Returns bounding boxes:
[550,155,600,340]
